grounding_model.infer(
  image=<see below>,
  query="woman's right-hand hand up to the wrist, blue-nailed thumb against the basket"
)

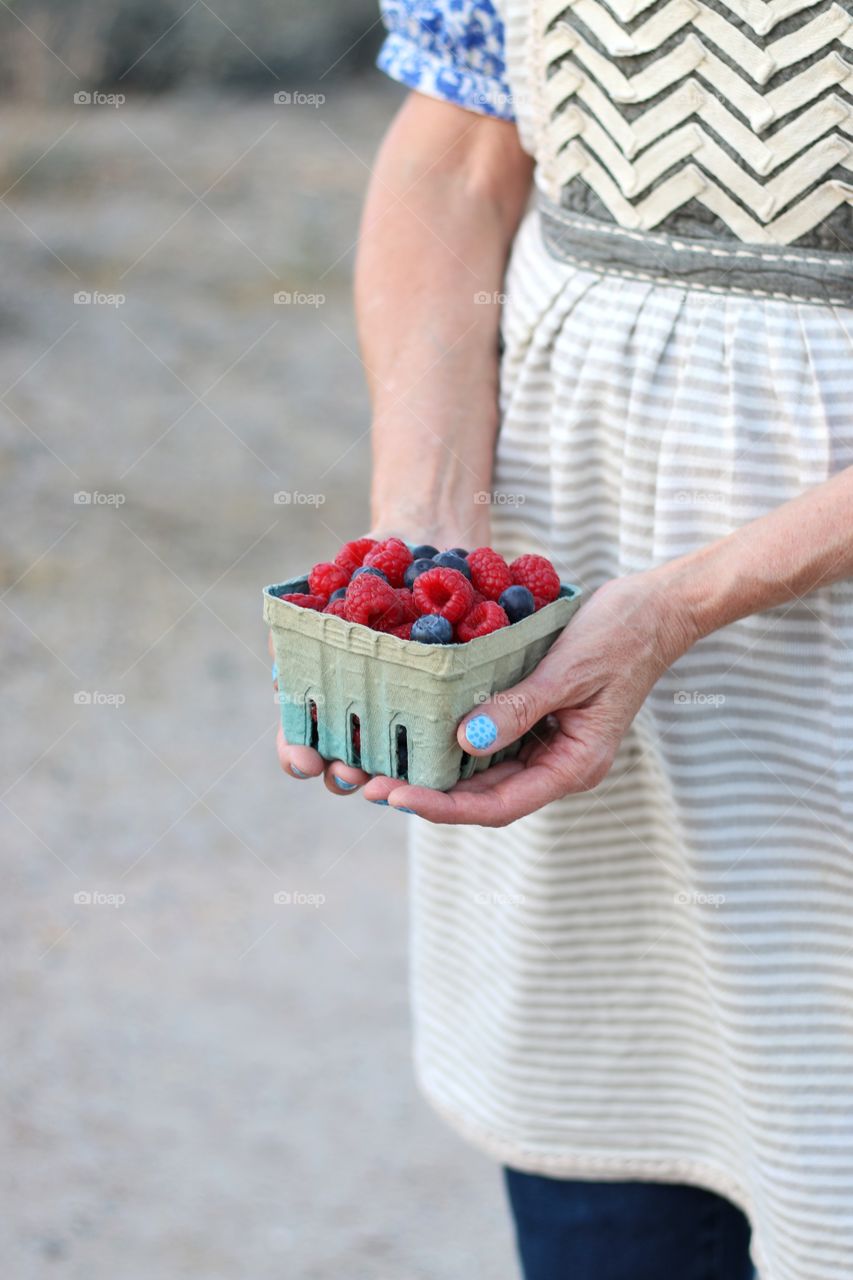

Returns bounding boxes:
[365,571,695,827]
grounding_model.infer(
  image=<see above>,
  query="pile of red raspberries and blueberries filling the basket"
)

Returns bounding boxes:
[275,538,560,644]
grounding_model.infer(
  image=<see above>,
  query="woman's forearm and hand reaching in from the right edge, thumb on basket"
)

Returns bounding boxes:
[365,467,853,827]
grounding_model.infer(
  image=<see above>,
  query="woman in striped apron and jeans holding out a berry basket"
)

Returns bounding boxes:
[279,0,853,1280]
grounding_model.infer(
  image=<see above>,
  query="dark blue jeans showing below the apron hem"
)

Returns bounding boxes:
[505,1169,754,1280]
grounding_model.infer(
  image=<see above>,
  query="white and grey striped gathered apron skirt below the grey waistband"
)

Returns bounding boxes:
[404,214,853,1280]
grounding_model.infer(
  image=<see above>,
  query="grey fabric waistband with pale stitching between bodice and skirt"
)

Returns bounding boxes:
[538,195,853,307]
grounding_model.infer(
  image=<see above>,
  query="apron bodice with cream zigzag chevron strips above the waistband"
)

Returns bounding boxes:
[530,0,853,251]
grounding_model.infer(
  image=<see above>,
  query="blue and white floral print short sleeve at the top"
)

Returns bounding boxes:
[377,0,514,120]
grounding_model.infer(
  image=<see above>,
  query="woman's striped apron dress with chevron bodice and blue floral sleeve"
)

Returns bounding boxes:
[382,0,853,1280]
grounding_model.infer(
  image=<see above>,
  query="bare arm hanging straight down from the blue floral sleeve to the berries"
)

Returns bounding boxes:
[356,93,530,539]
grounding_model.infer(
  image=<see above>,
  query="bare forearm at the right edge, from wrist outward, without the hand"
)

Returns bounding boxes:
[652,468,853,639]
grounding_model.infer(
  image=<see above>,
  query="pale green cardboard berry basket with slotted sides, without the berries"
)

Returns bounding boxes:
[264,577,583,791]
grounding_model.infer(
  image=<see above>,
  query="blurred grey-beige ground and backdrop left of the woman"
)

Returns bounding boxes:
[0,0,515,1280]
